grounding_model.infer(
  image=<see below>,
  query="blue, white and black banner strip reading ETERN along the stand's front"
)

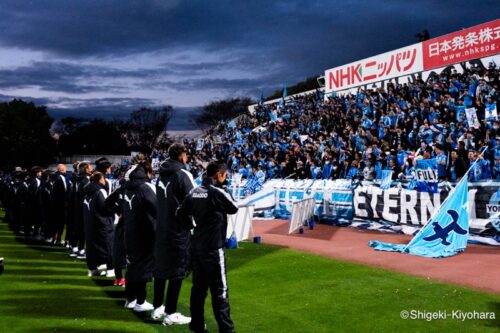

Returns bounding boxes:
[234,179,500,233]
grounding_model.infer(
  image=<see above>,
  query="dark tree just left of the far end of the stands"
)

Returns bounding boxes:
[122,105,174,152]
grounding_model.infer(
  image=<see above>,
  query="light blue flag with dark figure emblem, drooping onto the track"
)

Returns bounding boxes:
[368,177,469,258]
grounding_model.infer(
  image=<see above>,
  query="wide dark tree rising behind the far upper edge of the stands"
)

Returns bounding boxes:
[196,97,255,126]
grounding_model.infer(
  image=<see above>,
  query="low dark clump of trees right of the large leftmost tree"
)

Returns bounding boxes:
[58,118,129,155]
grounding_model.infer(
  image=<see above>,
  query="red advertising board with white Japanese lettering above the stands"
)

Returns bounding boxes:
[423,19,500,70]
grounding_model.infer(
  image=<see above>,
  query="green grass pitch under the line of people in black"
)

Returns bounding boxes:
[0,214,500,333]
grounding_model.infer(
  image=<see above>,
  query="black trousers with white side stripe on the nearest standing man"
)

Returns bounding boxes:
[189,249,234,333]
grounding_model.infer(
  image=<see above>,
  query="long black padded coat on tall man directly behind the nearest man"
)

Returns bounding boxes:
[155,159,195,280]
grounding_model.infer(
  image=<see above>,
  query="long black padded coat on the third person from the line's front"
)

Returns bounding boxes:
[122,166,157,282]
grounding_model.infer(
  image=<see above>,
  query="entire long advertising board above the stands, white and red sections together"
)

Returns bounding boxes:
[325,20,500,94]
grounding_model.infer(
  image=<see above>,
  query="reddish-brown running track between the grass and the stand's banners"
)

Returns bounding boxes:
[253,220,500,294]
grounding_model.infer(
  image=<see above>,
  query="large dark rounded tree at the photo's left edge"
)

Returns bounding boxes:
[0,99,55,168]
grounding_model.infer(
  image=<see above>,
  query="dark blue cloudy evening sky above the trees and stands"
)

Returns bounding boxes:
[0,0,499,112]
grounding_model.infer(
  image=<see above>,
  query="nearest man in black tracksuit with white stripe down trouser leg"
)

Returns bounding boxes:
[177,163,238,333]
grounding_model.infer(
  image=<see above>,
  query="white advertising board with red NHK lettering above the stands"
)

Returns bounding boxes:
[325,44,423,92]
